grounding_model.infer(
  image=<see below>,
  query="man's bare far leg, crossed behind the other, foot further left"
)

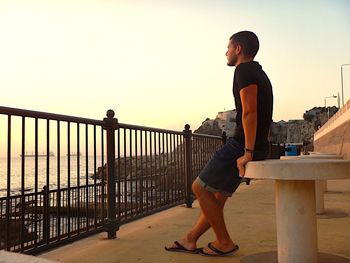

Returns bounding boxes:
[165,193,227,250]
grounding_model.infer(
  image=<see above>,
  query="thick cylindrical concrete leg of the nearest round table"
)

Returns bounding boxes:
[275,180,318,263]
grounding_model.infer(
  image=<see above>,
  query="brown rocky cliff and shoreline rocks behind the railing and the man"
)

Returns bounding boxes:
[92,107,337,183]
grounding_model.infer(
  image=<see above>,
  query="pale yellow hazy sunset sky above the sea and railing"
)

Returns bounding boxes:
[0,0,350,130]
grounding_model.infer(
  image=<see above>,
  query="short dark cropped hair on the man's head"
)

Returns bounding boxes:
[230,31,259,58]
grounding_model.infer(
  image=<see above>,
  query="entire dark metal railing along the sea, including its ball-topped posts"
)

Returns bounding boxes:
[0,107,226,254]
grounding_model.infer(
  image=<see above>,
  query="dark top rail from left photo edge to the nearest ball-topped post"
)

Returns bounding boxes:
[0,106,103,125]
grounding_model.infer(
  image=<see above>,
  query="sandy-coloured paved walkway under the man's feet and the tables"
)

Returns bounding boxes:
[39,180,350,263]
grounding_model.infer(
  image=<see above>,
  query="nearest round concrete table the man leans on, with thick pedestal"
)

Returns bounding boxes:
[241,158,350,263]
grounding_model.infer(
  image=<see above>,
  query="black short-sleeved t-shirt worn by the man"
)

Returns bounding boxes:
[233,61,273,151]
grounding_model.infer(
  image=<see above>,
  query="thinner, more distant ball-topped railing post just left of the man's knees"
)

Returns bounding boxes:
[183,124,193,208]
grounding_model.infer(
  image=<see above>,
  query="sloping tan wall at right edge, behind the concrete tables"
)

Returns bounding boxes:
[314,100,350,159]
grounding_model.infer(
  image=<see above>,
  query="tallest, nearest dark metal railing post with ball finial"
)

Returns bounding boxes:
[103,110,119,239]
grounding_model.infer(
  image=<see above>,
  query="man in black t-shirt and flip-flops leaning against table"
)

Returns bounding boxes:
[165,31,273,257]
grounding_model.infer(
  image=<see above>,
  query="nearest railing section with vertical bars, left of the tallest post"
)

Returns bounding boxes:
[0,107,106,253]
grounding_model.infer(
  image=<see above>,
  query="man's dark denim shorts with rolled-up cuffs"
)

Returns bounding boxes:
[196,139,268,197]
